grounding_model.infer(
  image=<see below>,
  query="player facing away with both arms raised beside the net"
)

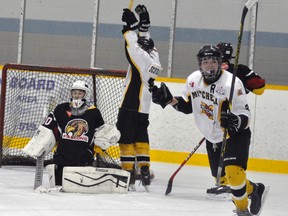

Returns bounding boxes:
[117,5,162,190]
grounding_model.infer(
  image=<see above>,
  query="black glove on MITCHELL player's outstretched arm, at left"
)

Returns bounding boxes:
[152,82,173,109]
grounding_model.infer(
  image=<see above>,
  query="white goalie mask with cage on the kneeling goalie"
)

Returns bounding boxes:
[70,80,90,109]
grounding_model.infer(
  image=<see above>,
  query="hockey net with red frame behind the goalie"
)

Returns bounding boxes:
[0,64,126,168]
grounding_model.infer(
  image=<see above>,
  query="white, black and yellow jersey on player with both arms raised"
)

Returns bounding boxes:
[120,31,162,114]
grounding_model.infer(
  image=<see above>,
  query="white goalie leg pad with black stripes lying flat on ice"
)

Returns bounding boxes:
[62,167,130,194]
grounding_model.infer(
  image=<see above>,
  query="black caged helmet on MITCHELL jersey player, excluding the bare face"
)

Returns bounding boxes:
[197,45,222,84]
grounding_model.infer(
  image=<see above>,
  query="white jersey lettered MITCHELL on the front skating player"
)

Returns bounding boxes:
[182,70,250,143]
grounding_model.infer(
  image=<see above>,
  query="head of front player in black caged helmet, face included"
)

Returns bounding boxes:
[197,45,222,85]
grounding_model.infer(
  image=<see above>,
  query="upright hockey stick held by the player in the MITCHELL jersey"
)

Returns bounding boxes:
[216,0,258,186]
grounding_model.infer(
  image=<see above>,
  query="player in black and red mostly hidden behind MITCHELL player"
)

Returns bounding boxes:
[206,42,265,199]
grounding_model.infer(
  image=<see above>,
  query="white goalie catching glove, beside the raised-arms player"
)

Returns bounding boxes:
[94,124,121,150]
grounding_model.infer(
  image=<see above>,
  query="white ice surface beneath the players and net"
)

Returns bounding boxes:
[0,162,288,216]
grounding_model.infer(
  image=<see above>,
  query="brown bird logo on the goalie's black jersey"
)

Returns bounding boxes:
[62,119,89,142]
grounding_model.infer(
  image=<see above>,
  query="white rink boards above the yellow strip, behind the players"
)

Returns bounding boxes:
[149,82,288,160]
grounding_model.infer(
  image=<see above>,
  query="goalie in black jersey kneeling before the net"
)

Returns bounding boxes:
[23,80,129,192]
